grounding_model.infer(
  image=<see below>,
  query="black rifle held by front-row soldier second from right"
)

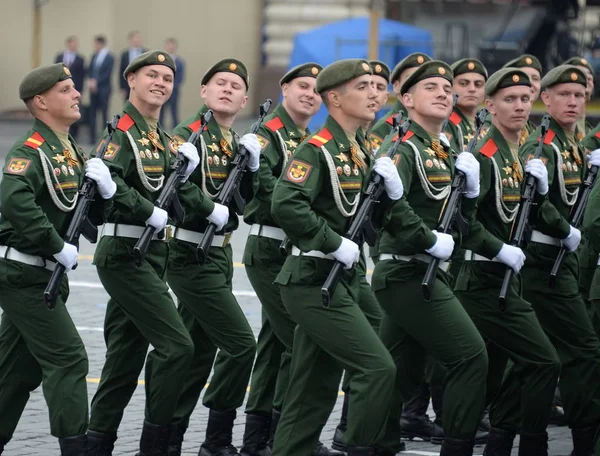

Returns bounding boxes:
[499,114,550,311]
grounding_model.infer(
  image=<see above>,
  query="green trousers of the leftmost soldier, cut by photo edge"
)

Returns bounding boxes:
[0,259,88,441]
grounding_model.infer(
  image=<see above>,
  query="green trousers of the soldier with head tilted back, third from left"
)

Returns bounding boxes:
[168,241,256,427]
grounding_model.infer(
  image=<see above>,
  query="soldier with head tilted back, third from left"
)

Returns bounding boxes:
[168,58,261,456]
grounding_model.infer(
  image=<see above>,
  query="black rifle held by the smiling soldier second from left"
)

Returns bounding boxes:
[133,109,212,268]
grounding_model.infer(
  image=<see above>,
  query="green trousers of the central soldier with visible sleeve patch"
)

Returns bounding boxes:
[273,266,395,456]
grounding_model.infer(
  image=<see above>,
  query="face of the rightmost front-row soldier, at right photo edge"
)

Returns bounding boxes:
[542,82,585,129]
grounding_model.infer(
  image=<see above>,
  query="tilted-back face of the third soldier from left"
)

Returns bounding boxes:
[200,71,248,115]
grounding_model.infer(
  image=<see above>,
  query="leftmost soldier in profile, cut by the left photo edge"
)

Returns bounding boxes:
[0,63,115,456]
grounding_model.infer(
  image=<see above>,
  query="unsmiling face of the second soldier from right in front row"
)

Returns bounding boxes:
[485,86,531,133]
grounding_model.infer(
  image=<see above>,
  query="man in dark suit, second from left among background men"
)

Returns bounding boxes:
[88,35,115,144]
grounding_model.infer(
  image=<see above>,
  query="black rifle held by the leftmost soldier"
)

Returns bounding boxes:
[44,114,121,310]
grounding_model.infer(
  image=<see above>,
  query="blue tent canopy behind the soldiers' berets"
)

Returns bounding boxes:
[289,17,433,131]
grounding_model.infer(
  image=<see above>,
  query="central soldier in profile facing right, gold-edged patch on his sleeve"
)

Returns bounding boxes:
[272,59,402,456]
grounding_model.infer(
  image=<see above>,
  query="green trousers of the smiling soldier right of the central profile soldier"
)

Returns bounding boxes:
[373,260,488,451]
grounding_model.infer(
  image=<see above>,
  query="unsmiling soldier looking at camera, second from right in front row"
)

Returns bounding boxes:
[454,67,560,456]
